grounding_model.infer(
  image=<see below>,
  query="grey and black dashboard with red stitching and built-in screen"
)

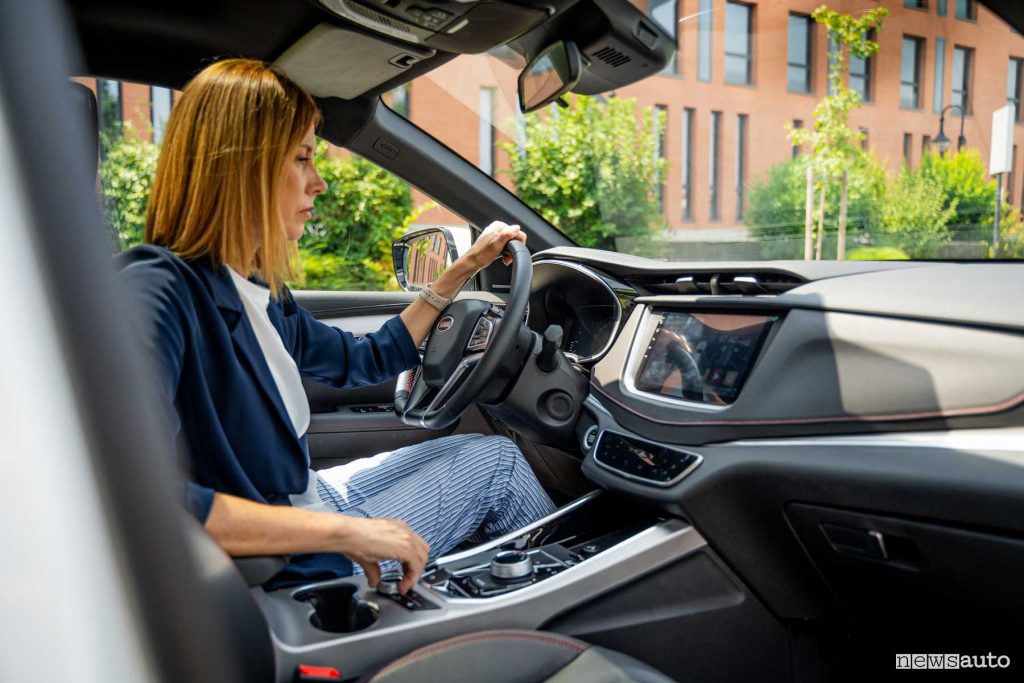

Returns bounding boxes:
[530,248,1024,643]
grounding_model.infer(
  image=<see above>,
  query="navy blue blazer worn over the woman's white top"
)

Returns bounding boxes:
[120,245,420,586]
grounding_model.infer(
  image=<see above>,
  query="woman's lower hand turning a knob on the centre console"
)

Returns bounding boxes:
[339,516,430,593]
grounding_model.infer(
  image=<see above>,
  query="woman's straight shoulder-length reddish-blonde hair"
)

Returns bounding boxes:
[145,59,321,297]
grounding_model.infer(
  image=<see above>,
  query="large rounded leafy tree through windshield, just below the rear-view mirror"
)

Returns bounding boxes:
[504,96,667,249]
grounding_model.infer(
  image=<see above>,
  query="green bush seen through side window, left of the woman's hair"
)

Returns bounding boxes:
[99,127,160,251]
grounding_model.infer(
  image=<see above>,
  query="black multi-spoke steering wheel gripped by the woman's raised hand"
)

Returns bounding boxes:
[394,240,534,429]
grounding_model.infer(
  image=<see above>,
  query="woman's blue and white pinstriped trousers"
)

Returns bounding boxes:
[316,434,555,572]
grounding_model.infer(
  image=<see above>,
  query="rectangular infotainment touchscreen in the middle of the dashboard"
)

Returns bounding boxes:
[634,311,776,405]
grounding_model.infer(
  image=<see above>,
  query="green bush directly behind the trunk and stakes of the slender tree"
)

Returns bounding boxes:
[746,153,886,258]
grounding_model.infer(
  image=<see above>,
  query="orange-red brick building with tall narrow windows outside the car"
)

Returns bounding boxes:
[81,0,1024,245]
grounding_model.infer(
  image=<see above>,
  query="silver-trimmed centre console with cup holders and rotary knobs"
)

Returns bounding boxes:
[253,492,705,680]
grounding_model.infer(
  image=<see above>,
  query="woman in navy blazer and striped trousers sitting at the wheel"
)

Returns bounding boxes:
[122,59,554,592]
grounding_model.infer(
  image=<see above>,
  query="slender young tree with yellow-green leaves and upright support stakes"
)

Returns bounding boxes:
[790,5,889,259]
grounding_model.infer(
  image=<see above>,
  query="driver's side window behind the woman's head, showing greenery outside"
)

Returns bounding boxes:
[79,79,470,291]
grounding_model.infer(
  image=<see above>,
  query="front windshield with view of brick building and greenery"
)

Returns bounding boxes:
[389,0,1024,260]
